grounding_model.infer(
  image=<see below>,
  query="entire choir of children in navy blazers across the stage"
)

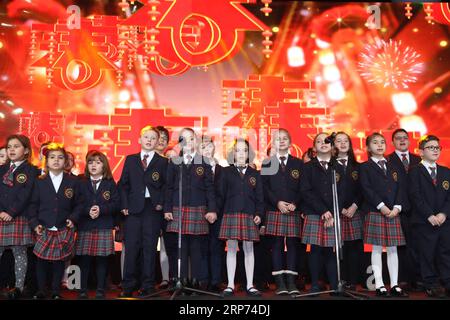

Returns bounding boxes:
[0,126,450,299]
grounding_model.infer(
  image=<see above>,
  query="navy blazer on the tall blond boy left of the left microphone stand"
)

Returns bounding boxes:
[118,152,168,214]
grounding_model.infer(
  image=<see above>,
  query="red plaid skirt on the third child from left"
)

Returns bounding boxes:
[76,229,114,257]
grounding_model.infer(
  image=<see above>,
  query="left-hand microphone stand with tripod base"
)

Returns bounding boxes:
[143,159,223,300]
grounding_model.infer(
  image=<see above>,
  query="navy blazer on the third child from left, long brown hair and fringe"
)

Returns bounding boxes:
[78,178,120,231]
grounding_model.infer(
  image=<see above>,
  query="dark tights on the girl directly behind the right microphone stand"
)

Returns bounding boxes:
[309,244,337,290]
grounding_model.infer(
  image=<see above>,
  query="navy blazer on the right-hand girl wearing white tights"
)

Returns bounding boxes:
[360,159,404,213]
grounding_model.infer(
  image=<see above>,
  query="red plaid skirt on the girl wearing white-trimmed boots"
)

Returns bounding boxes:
[265,211,302,238]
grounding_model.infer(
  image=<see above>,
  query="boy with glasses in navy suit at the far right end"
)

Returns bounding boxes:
[408,135,450,298]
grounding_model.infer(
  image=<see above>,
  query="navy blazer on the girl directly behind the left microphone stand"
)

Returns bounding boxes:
[164,153,217,212]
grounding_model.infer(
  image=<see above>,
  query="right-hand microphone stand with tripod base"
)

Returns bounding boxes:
[292,160,369,300]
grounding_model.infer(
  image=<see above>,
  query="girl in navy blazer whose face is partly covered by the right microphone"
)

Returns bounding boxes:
[300,133,344,293]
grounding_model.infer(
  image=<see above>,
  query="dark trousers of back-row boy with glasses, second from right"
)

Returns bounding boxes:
[397,212,421,283]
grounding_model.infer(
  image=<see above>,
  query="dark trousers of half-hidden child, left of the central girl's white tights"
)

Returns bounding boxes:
[207,219,225,286]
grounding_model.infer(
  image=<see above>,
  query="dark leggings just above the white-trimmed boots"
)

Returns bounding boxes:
[272,237,299,271]
